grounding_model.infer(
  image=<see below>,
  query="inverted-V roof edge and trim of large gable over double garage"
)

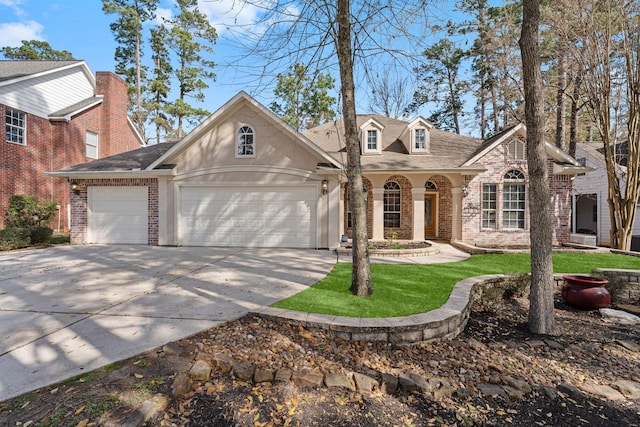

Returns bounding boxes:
[147,91,342,170]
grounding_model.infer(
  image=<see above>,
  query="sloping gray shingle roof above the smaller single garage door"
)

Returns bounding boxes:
[57,141,177,172]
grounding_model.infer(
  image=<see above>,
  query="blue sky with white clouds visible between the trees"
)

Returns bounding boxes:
[0,0,478,137]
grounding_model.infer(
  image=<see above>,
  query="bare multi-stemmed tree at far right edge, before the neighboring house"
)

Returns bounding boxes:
[567,0,640,250]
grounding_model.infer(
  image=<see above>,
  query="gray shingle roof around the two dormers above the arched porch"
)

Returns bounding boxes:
[304,114,484,172]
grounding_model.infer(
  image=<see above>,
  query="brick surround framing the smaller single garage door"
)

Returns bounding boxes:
[71,178,158,245]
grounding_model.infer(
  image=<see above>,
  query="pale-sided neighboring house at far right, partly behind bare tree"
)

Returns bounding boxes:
[573,142,640,246]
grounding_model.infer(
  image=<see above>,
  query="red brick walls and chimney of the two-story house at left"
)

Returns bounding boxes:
[0,72,140,230]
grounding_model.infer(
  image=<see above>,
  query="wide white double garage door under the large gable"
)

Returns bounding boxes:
[180,186,317,248]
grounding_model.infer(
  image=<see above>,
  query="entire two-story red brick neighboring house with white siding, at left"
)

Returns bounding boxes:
[0,61,143,229]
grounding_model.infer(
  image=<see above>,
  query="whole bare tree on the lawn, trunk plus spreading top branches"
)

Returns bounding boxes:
[228,0,432,296]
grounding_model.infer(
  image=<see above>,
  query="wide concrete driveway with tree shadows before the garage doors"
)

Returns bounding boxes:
[0,245,336,401]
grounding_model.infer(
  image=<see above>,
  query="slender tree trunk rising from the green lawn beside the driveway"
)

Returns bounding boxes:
[336,0,373,296]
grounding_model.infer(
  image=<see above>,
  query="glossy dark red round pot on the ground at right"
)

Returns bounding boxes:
[562,274,611,310]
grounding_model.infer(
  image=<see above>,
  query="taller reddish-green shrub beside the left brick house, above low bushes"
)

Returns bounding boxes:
[5,194,57,228]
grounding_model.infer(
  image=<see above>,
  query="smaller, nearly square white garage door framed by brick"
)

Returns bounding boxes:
[87,187,149,245]
